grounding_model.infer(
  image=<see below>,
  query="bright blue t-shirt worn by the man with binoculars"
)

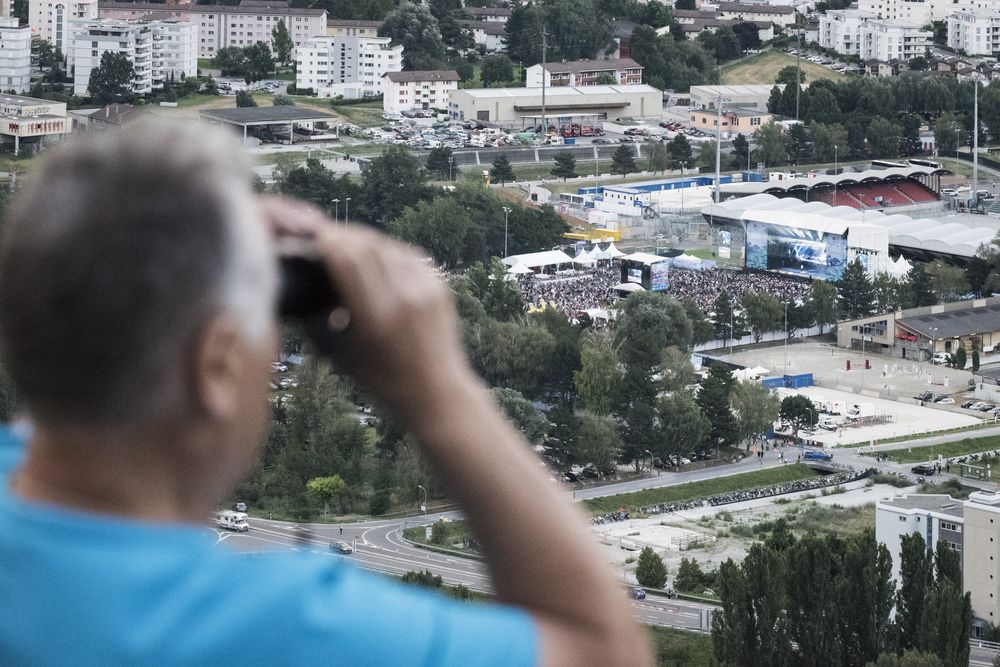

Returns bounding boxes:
[0,430,538,666]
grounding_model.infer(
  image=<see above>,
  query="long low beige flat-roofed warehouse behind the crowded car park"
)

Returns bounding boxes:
[448,85,663,128]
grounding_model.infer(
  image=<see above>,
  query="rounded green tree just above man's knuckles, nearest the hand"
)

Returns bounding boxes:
[387,197,472,268]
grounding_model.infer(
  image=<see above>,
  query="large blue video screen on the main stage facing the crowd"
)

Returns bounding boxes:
[746,221,847,281]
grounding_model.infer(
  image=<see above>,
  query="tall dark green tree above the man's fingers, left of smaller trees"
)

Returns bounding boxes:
[360,146,427,227]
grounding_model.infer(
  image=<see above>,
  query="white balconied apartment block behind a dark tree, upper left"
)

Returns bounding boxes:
[67,20,198,95]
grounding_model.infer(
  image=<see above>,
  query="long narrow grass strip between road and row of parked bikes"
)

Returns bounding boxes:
[583,464,817,513]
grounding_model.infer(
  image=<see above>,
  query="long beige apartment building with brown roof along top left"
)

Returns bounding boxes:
[100,0,327,58]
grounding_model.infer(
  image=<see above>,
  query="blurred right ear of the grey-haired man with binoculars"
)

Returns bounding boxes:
[191,315,246,420]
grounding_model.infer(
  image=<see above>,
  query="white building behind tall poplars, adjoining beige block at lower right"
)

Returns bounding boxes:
[875,493,974,588]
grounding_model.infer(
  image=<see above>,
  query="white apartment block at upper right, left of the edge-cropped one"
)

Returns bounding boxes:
[819,9,934,61]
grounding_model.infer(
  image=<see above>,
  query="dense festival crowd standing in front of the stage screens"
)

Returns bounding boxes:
[518,262,809,317]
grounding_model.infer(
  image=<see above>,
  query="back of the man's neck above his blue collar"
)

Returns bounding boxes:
[10,431,218,523]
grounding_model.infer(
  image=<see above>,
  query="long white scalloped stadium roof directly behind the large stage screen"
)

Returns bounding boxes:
[701,193,997,258]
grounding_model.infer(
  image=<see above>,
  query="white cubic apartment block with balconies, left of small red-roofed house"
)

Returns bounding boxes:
[295,37,403,99]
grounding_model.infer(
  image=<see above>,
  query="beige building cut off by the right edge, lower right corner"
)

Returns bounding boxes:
[962,491,1000,636]
